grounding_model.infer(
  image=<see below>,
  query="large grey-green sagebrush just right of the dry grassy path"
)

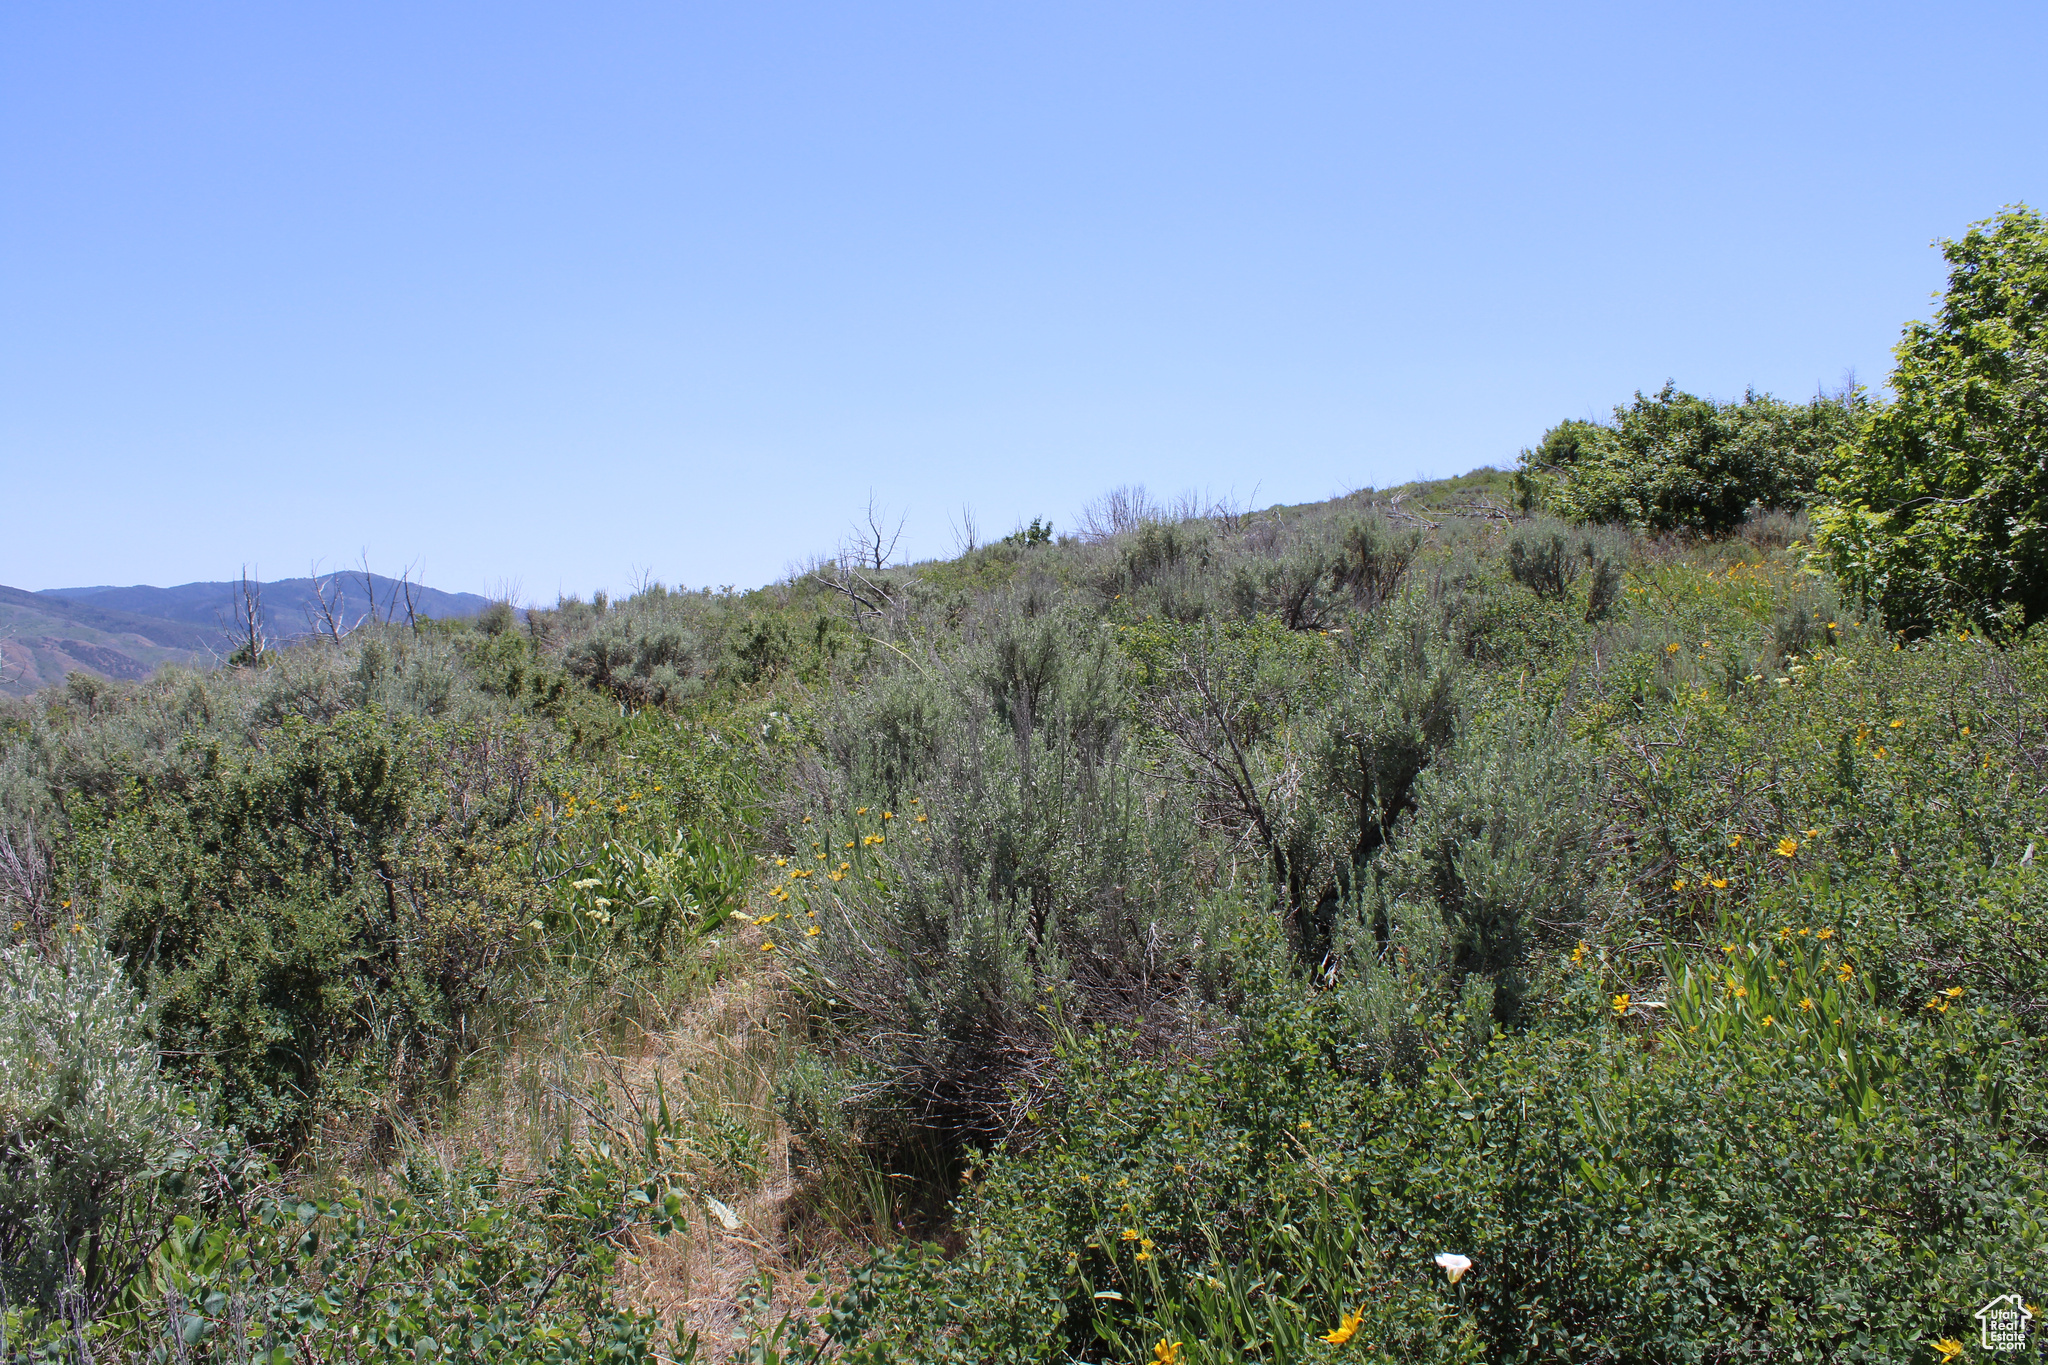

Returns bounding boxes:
[772,600,1190,1148]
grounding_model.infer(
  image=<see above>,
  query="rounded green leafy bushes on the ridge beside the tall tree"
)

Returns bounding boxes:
[1518,383,1862,532]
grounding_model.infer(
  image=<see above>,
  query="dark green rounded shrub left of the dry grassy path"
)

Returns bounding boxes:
[70,708,535,1148]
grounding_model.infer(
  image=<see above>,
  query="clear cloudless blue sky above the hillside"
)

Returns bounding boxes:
[0,0,2048,600]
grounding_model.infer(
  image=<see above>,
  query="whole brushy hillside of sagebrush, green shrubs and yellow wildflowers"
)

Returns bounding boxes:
[0,211,2048,1365]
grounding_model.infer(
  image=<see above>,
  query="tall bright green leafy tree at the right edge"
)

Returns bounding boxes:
[1815,205,2048,630]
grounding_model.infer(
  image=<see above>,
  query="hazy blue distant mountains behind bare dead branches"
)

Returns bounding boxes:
[0,573,489,696]
